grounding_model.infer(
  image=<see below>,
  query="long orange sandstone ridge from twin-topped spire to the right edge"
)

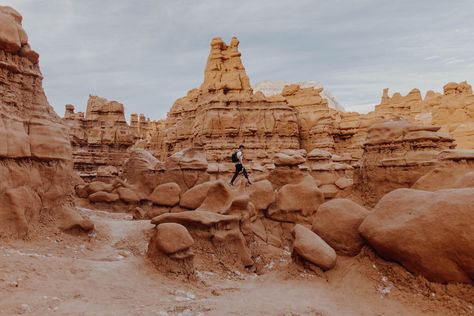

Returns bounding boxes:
[150,38,474,170]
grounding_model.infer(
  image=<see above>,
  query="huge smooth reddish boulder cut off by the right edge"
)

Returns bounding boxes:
[359,188,474,283]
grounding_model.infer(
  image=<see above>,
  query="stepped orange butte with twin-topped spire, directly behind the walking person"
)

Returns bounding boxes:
[152,38,300,162]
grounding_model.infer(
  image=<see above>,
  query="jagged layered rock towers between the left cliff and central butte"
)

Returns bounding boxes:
[63,96,160,177]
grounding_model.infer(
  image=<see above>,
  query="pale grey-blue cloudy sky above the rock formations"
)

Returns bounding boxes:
[2,0,474,118]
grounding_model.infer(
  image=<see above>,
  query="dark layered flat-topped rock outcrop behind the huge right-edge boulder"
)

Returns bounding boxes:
[355,120,454,205]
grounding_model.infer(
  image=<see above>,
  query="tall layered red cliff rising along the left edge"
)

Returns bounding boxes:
[0,6,93,237]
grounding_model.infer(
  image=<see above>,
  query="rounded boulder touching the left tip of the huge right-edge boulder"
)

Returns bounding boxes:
[312,199,369,256]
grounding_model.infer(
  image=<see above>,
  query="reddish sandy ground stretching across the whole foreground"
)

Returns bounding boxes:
[0,209,474,315]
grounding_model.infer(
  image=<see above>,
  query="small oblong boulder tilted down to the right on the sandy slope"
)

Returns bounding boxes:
[293,224,337,270]
